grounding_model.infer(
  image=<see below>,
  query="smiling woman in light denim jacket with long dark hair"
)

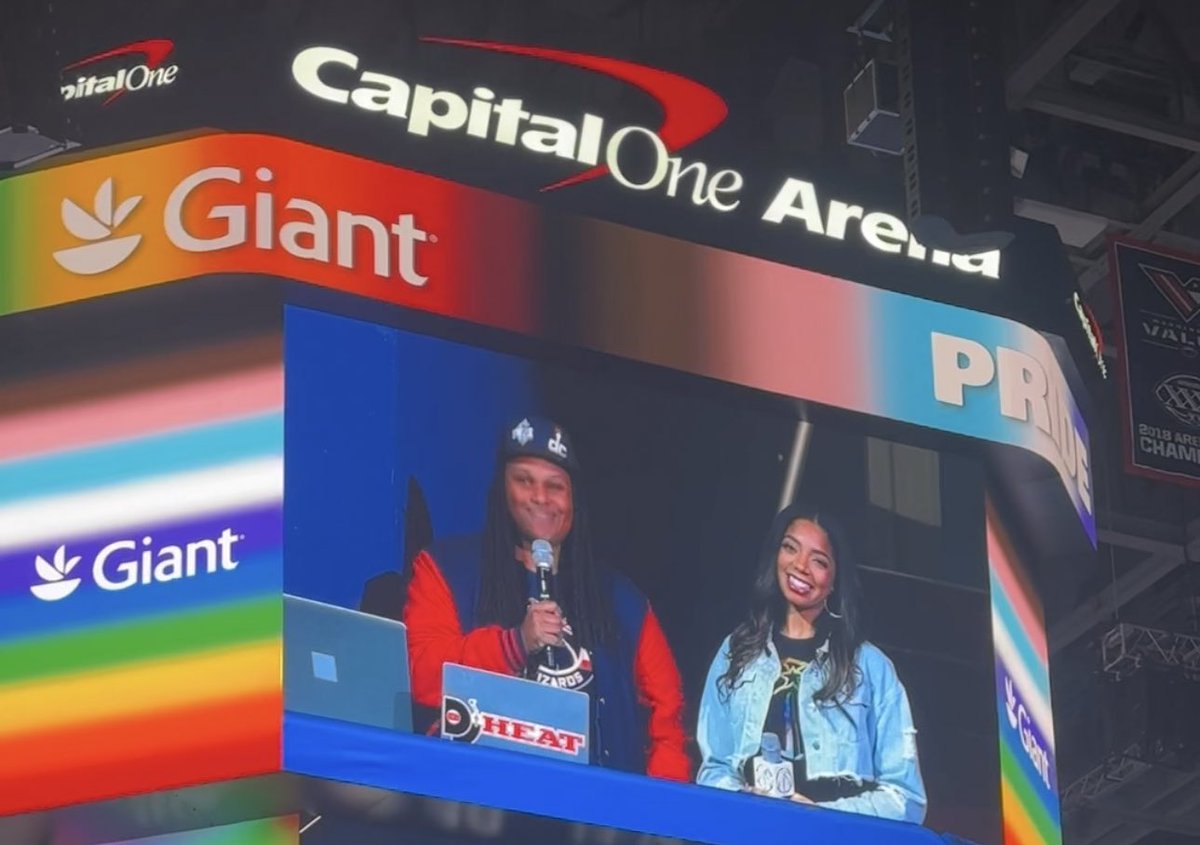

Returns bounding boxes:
[696,504,925,822]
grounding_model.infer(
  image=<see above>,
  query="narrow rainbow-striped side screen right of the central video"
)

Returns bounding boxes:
[988,504,1062,845]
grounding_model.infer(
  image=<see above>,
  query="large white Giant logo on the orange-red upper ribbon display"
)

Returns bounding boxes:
[54,167,438,287]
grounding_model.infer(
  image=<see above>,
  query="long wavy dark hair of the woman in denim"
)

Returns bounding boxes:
[719,504,863,703]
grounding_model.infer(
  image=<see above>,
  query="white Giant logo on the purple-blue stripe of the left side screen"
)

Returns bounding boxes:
[29,528,246,601]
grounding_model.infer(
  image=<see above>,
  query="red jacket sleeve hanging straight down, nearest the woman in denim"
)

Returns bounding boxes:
[634,607,691,783]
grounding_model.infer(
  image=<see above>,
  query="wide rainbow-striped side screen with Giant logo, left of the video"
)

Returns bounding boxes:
[0,336,283,816]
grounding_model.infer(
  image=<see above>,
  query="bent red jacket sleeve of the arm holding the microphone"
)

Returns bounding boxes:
[404,552,526,707]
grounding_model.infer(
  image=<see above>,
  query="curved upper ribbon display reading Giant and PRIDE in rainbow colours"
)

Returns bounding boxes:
[0,134,1096,545]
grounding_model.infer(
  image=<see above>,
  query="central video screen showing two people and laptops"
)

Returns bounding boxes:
[284,307,1002,843]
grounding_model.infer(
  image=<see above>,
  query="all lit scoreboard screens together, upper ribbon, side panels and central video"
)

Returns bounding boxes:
[0,118,1080,843]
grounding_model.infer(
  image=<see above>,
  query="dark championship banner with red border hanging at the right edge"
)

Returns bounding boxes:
[1110,241,1200,486]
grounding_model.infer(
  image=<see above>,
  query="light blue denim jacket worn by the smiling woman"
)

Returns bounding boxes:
[696,637,925,825]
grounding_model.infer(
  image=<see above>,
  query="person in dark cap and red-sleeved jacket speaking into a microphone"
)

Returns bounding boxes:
[404,416,690,781]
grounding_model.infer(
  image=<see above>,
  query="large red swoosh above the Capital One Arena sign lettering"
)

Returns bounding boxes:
[421,37,730,191]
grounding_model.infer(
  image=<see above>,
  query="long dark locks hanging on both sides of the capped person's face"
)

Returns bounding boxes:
[475,459,617,646]
